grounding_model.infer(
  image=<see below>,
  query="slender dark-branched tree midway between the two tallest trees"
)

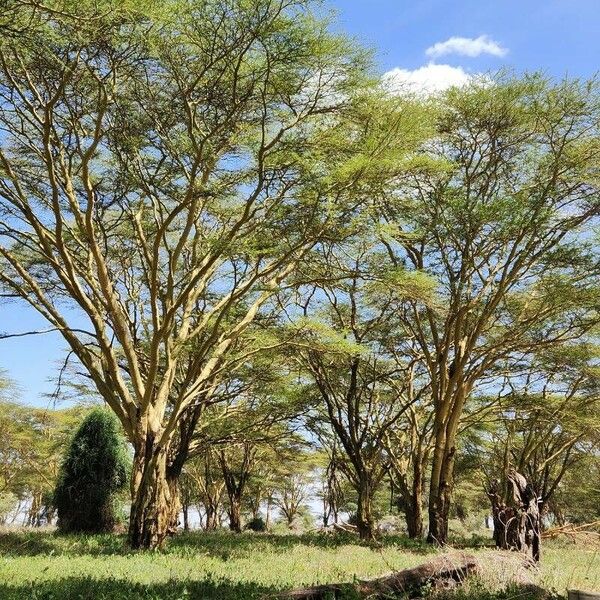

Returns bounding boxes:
[292,238,434,539]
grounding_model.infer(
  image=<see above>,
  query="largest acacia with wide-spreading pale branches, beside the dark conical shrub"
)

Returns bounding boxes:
[0,0,377,547]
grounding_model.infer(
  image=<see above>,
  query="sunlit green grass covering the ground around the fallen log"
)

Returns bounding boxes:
[0,531,600,600]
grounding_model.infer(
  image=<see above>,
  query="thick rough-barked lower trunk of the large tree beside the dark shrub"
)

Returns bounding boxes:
[129,444,174,549]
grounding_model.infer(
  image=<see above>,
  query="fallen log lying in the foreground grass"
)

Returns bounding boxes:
[279,554,479,600]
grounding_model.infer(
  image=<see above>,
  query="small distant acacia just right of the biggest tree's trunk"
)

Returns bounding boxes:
[177,346,300,533]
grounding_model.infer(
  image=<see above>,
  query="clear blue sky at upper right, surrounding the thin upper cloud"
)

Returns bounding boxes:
[329,0,600,77]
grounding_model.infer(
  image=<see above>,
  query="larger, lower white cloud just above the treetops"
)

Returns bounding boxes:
[382,63,472,94]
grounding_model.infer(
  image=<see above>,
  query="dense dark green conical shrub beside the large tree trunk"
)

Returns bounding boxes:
[54,409,129,533]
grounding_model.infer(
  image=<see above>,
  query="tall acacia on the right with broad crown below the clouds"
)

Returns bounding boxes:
[382,76,600,543]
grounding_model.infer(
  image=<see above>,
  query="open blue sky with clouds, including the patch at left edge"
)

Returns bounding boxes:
[0,0,600,404]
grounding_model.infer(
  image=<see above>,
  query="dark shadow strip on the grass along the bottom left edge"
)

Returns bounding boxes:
[0,577,278,600]
